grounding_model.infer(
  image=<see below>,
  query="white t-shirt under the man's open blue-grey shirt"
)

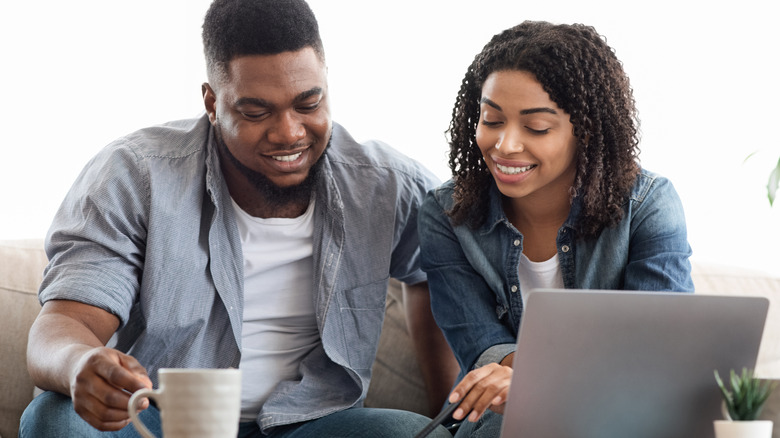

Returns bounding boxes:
[233,199,321,421]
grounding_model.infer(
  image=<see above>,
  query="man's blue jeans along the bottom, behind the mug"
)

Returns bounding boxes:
[19,392,452,438]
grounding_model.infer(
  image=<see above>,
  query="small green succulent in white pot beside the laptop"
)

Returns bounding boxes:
[714,368,777,438]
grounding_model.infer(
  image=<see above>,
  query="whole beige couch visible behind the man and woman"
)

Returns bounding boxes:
[0,240,780,438]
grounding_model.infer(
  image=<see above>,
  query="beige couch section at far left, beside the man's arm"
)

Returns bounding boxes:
[0,240,46,437]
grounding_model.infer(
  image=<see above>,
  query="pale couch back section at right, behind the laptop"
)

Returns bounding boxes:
[693,262,780,379]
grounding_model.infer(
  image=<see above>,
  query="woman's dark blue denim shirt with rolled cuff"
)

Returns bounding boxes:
[419,170,693,377]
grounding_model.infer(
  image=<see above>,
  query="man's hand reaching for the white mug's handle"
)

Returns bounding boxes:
[70,347,152,431]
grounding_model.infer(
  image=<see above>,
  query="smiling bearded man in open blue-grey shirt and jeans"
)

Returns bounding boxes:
[20,0,454,437]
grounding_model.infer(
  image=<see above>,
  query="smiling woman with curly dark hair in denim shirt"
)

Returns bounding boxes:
[420,22,693,436]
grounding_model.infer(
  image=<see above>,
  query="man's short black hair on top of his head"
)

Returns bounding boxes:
[203,0,325,85]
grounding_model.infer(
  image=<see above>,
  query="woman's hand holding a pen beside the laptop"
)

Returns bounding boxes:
[449,353,514,422]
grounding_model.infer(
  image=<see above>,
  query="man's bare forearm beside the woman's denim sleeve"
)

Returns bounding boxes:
[403,282,459,416]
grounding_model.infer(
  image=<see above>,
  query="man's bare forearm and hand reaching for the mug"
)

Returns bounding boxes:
[27,300,152,430]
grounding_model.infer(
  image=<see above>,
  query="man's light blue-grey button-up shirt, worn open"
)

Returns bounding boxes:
[39,115,438,430]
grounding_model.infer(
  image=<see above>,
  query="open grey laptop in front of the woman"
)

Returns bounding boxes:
[501,289,769,438]
